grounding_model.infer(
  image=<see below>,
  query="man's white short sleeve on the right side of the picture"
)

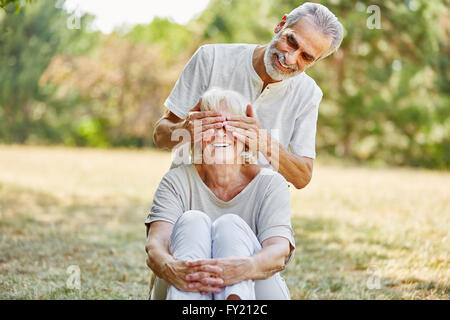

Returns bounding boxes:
[289,87,323,159]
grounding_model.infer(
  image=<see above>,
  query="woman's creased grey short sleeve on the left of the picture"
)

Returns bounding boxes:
[145,174,183,231]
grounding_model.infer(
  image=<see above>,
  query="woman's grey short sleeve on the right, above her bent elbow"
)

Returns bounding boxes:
[256,173,295,264]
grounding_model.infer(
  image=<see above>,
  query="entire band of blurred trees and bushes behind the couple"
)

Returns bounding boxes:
[0,0,450,169]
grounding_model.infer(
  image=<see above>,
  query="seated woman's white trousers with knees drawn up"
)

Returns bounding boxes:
[166,210,290,300]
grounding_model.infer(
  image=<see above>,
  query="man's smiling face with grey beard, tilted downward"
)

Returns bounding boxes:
[264,16,331,81]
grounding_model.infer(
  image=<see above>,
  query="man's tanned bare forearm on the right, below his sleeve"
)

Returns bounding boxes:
[261,138,313,189]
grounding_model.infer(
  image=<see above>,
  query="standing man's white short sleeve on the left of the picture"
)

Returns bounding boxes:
[164,45,212,119]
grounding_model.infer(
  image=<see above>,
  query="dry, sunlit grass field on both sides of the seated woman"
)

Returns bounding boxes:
[0,146,450,299]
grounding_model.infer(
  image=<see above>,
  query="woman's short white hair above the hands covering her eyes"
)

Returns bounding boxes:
[200,87,250,115]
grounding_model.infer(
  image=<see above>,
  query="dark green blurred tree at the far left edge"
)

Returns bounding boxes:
[0,1,95,143]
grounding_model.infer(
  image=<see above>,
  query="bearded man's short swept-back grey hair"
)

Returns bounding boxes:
[286,2,344,59]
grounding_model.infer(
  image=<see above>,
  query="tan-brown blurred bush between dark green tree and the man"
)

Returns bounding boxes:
[41,35,177,146]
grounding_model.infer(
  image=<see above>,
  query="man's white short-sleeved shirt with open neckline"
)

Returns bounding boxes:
[164,44,322,165]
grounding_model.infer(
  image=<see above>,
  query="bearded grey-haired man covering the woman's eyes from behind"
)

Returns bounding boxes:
[154,3,343,189]
